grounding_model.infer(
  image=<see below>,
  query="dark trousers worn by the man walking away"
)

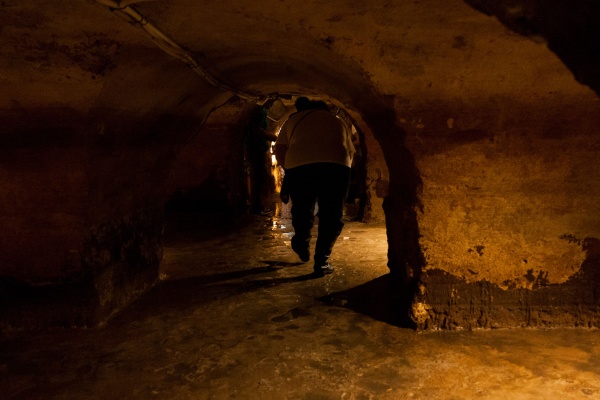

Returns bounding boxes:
[285,163,350,265]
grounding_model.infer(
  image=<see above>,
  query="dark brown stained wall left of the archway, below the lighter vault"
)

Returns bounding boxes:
[0,108,197,329]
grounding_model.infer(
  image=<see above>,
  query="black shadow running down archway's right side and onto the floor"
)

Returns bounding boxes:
[358,102,425,327]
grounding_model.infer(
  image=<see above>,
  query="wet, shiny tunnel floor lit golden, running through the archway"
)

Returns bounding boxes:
[0,205,600,400]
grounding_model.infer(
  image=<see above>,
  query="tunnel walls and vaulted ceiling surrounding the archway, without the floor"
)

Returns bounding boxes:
[0,0,600,331]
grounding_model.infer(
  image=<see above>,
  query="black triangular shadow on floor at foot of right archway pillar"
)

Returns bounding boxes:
[319,274,415,329]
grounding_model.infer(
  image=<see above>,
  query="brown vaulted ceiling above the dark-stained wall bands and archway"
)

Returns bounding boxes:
[0,0,598,117]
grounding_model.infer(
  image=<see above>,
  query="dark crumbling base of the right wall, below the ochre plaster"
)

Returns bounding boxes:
[411,238,600,331]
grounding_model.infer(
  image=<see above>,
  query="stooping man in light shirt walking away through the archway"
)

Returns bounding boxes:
[275,97,355,276]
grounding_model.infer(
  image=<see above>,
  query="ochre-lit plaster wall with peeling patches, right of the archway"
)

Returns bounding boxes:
[399,96,600,329]
